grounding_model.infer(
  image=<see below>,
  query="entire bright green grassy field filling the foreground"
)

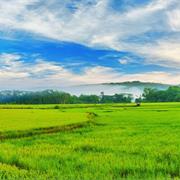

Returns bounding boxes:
[0,103,180,180]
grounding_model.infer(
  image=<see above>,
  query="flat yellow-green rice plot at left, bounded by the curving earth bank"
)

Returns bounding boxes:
[0,109,87,132]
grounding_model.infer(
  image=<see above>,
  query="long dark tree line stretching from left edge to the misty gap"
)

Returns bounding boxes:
[0,90,133,104]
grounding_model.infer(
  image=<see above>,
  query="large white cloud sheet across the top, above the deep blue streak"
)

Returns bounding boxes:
[0,0,178,46]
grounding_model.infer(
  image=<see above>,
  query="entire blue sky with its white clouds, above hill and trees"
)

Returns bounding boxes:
[0,0,180,89]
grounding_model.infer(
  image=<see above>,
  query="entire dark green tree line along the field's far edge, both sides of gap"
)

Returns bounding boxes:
[0,86,180,104]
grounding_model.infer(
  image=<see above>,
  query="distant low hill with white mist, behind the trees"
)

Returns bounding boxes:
[63,81,171,97]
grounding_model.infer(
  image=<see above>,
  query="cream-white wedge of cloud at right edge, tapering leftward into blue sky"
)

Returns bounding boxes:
[124,39,180,69]
